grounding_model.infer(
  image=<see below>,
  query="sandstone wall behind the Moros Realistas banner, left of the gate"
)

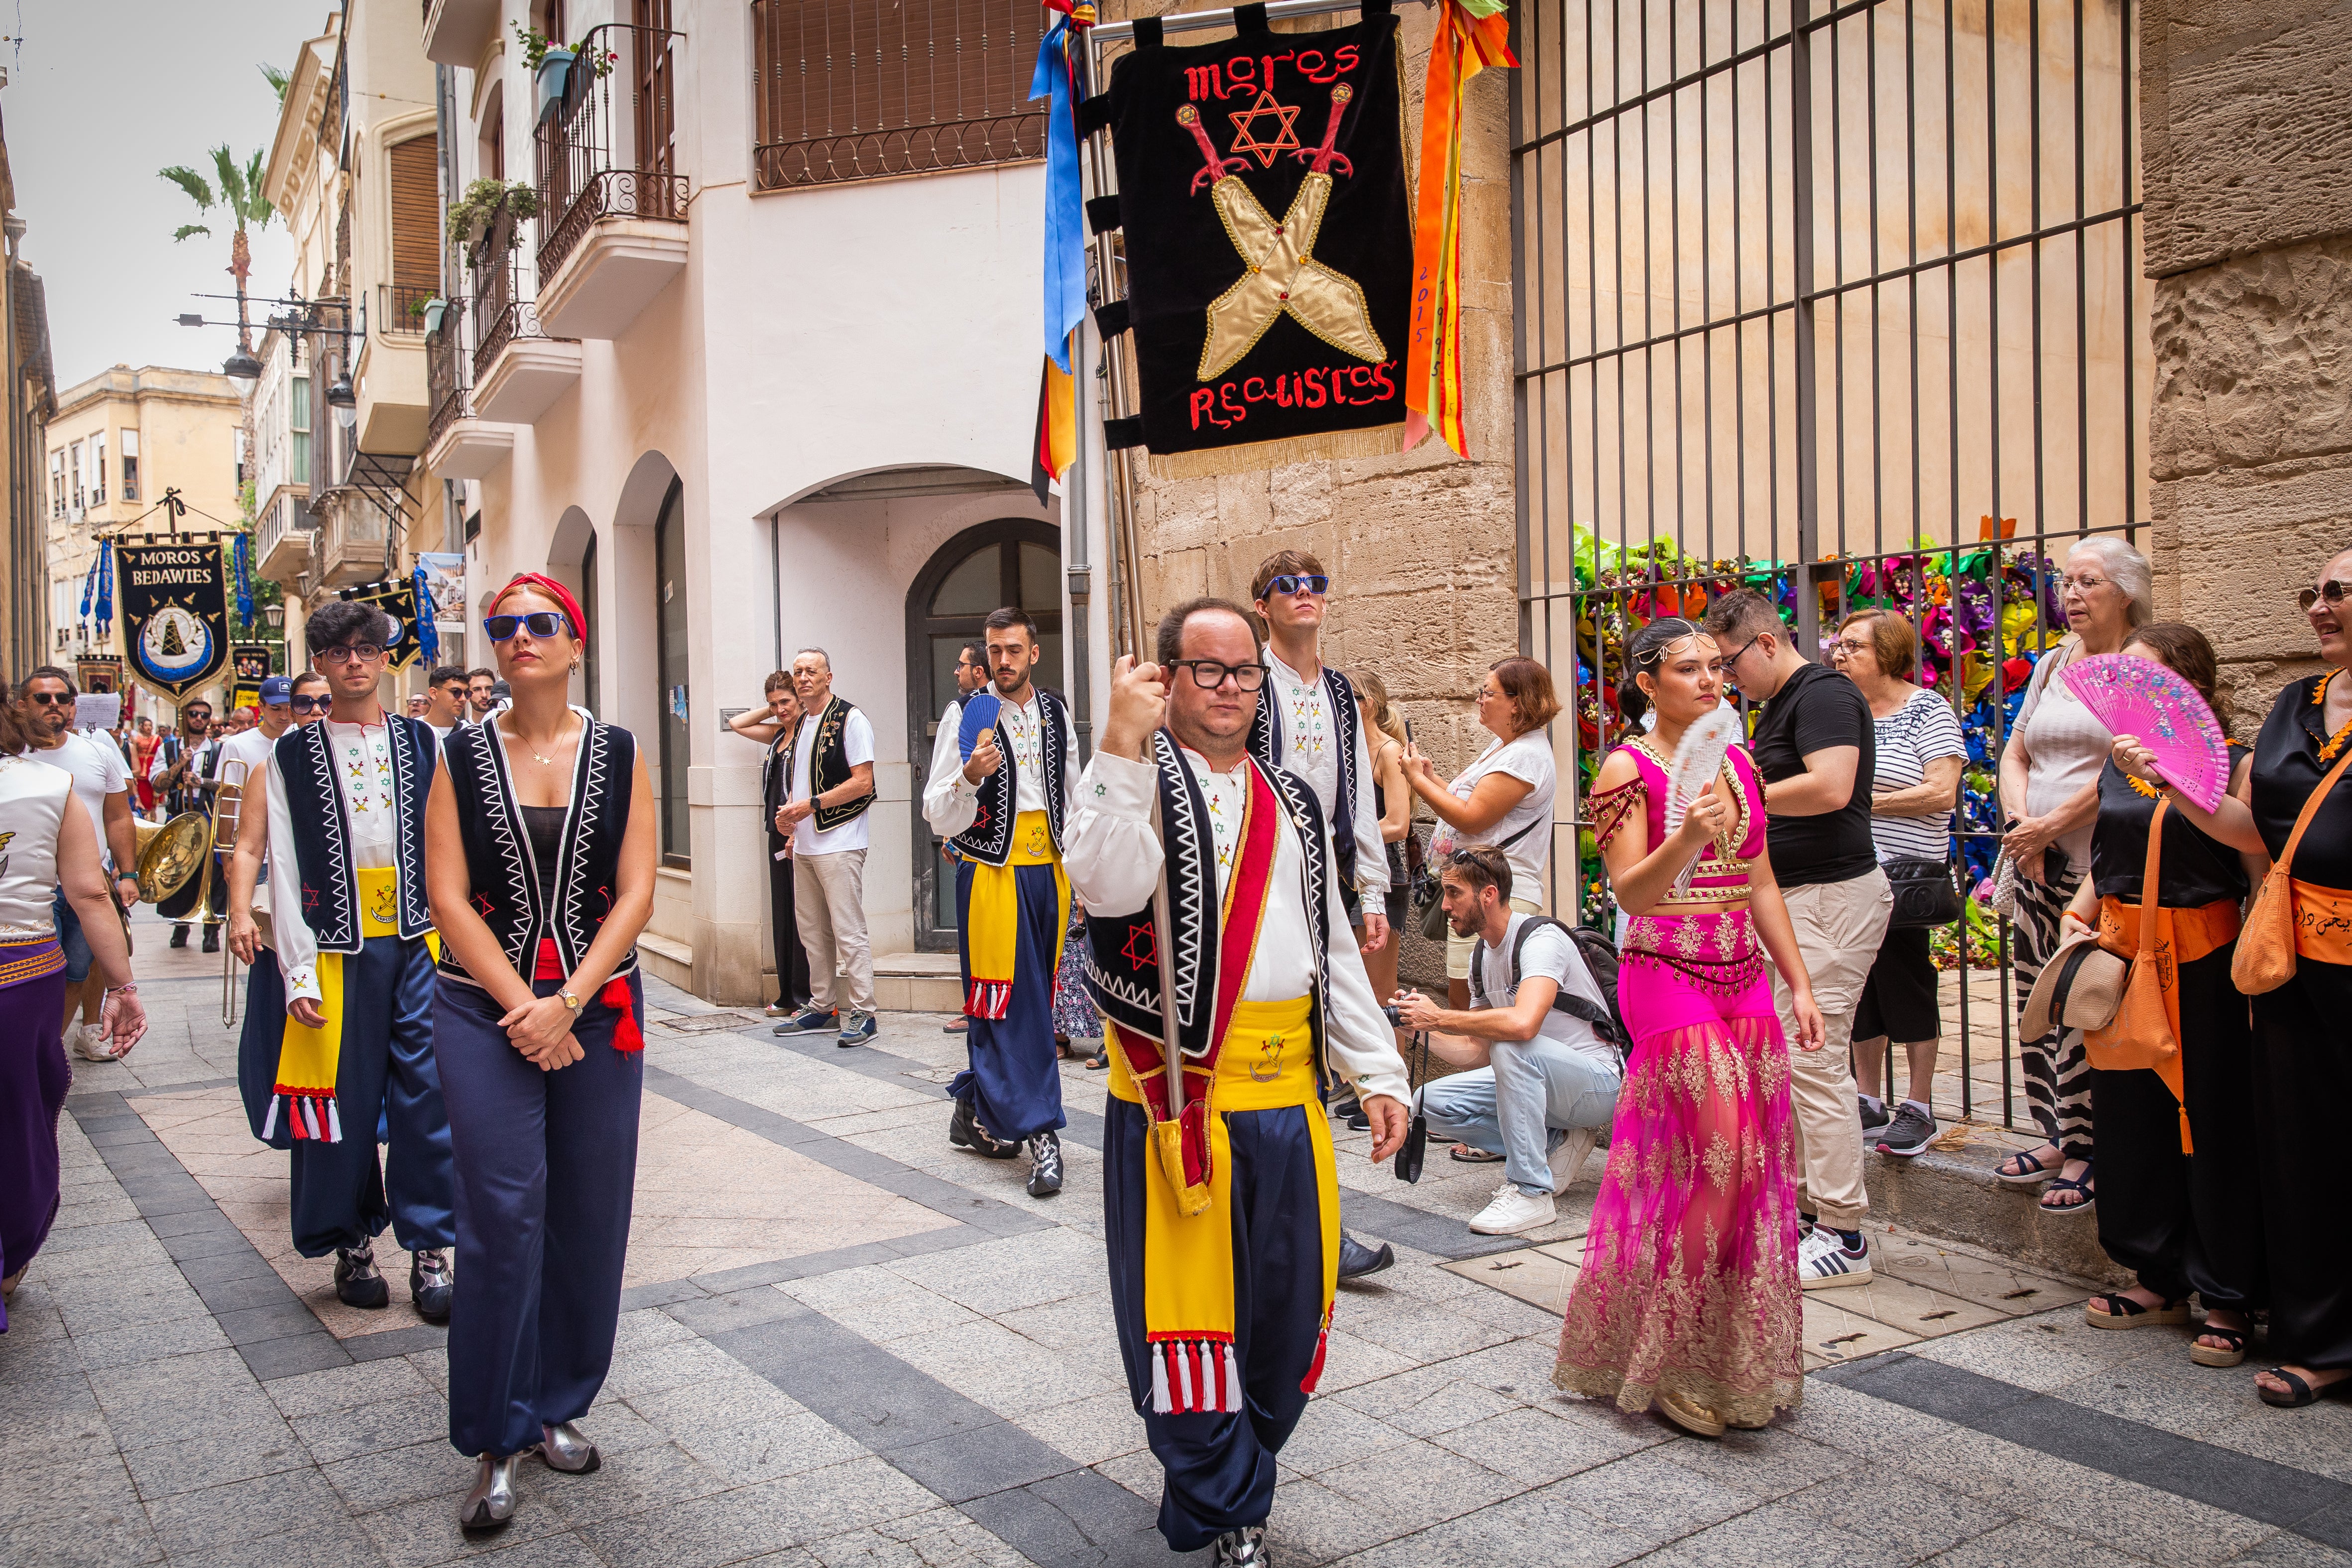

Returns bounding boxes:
[1103,0,1520,980]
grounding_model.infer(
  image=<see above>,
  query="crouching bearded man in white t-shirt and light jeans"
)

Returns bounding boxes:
[1395,844,1625,1236]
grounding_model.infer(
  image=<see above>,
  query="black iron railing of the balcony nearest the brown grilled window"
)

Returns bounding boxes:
[532,21,689,277]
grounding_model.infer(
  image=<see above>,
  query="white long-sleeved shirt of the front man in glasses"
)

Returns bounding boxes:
[1061,747,1411,1100]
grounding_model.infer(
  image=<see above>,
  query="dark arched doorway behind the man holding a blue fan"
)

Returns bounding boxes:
[906,517,1061,952]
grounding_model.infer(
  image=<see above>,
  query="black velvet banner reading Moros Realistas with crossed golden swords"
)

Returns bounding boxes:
[1105,0,1413,473]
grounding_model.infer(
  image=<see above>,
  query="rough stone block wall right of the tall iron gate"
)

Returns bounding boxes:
[2140,0,2352,731]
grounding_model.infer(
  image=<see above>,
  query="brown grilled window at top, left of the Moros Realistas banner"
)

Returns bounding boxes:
[750,0,1047,190]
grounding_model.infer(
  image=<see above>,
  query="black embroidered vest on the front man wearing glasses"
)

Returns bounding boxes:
[1086,729,1331,1058]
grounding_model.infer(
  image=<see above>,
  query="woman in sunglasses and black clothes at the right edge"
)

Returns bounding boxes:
[2115,550,2352,1411]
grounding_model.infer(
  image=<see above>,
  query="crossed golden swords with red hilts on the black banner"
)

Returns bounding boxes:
[1176,82,1388,381]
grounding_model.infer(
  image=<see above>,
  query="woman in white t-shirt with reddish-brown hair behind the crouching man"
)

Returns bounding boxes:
[1402,658,1559,1013]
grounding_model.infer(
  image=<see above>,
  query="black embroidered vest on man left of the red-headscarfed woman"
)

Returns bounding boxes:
[273,713,440,952]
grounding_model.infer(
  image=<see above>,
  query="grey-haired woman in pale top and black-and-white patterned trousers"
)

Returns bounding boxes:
[1995,536,2154,1213]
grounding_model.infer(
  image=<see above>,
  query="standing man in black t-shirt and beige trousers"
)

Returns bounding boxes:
[1708,588,1893,1291]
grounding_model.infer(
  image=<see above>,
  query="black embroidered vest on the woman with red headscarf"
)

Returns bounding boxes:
[440,708,637,980]
